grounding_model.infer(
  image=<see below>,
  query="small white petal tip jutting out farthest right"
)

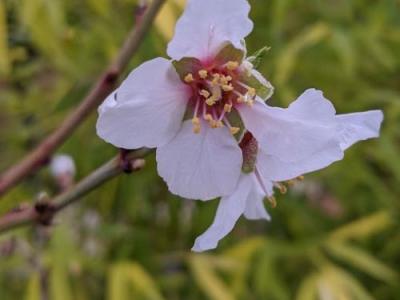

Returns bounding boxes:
[336,110,383,150]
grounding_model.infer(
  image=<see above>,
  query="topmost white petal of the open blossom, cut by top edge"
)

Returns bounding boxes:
[167,0,253,60]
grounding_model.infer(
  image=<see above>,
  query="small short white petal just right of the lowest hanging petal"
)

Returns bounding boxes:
[244,174,272,221]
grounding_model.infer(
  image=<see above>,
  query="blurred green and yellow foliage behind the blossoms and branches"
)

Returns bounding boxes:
[0,0,400,300]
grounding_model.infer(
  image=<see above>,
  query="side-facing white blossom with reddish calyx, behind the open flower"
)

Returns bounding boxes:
[192,89,383,252]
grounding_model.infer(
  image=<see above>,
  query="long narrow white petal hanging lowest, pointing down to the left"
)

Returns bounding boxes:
[192,174,253,252]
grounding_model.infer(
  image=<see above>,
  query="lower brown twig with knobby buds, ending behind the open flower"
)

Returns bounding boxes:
[0,149,151,233]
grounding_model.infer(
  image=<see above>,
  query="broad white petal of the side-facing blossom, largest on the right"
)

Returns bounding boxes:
[238,99,338,162]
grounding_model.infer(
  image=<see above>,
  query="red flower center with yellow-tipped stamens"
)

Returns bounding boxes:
[184,61,256,135]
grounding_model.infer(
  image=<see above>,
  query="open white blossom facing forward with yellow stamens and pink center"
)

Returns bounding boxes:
[97,0,272,200]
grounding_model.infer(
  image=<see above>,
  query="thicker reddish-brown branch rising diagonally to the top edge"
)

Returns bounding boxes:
[0,0,165,196]
